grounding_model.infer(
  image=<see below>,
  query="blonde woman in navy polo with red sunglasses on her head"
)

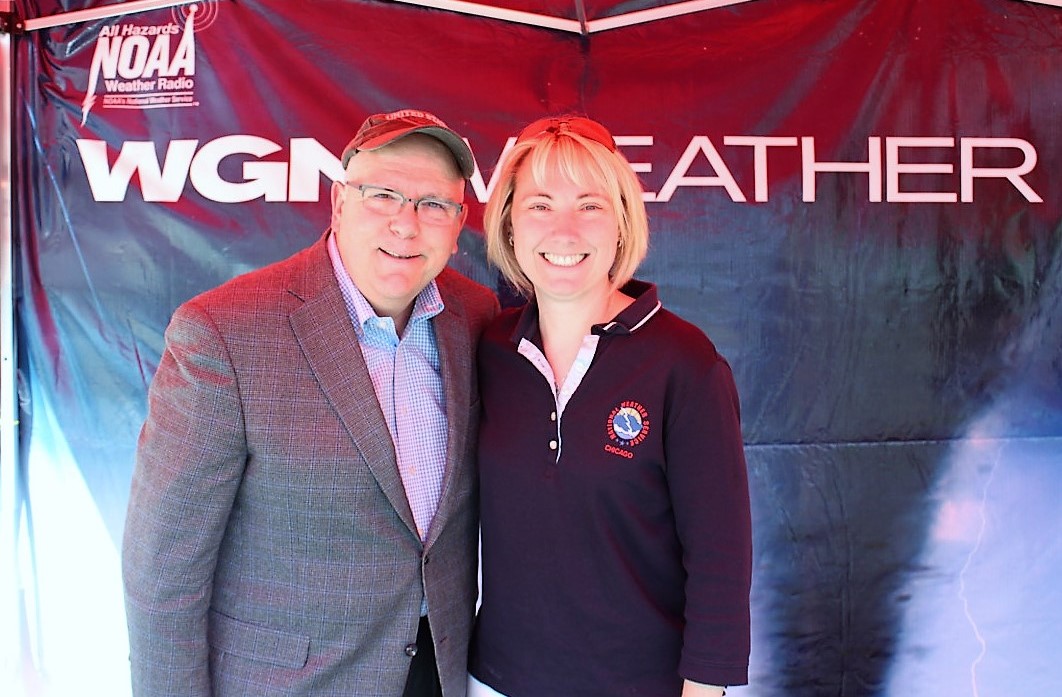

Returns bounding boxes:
[469,116,752,697]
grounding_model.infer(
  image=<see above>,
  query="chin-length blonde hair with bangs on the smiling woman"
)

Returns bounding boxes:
[483,115,649,298]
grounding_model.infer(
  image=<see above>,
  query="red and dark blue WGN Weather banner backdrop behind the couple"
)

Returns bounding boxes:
[0,0,1062,697]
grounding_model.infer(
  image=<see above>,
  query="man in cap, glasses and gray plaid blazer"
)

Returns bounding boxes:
[122,109,498,697]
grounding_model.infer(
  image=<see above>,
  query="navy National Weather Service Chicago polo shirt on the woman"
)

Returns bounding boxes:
[472,281,752,697]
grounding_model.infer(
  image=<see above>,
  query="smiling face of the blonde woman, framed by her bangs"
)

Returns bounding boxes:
[512,162,619,301]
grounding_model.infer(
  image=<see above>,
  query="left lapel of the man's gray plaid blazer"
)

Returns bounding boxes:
[289,254,419,540]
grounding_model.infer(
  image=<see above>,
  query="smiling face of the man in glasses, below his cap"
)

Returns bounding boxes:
[331,134,467,329]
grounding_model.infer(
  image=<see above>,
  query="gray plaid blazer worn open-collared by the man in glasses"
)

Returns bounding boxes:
[122,238,498,697]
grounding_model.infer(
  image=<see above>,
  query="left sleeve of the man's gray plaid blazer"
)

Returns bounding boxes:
[122,301,246,697]
